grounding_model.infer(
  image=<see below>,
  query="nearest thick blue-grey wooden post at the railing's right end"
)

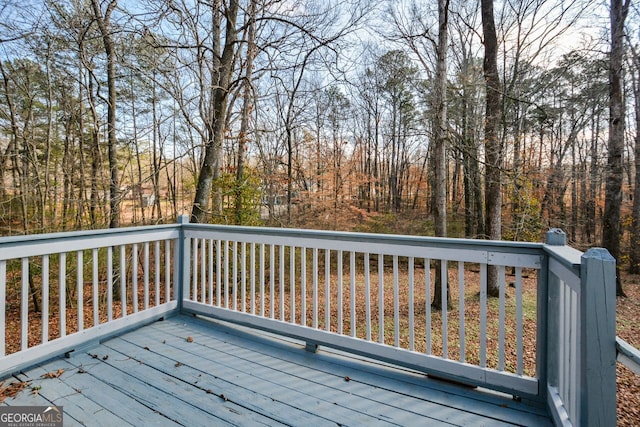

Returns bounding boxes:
[580,248,616,426]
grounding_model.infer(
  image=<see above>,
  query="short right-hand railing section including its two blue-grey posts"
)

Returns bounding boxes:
[545,230,616,426]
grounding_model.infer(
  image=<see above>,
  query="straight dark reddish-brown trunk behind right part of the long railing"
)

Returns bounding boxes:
[481,0,502,296]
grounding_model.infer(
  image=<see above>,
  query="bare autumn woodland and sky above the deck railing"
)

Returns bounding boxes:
[0,0,640,286]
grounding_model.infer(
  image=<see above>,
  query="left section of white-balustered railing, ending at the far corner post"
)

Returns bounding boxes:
[0,226,180,376]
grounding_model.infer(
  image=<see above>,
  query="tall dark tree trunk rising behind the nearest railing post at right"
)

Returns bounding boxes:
[602,0,629,296]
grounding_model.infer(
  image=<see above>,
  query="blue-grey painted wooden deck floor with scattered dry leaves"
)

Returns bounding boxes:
[3,315,551,426]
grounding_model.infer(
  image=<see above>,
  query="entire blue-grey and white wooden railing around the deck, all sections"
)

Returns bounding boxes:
[0,217,616,425]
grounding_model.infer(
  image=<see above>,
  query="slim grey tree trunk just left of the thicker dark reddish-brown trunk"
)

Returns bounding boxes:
[431,0,451,310]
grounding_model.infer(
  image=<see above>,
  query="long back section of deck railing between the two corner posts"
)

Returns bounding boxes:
[183,225,544,396]
